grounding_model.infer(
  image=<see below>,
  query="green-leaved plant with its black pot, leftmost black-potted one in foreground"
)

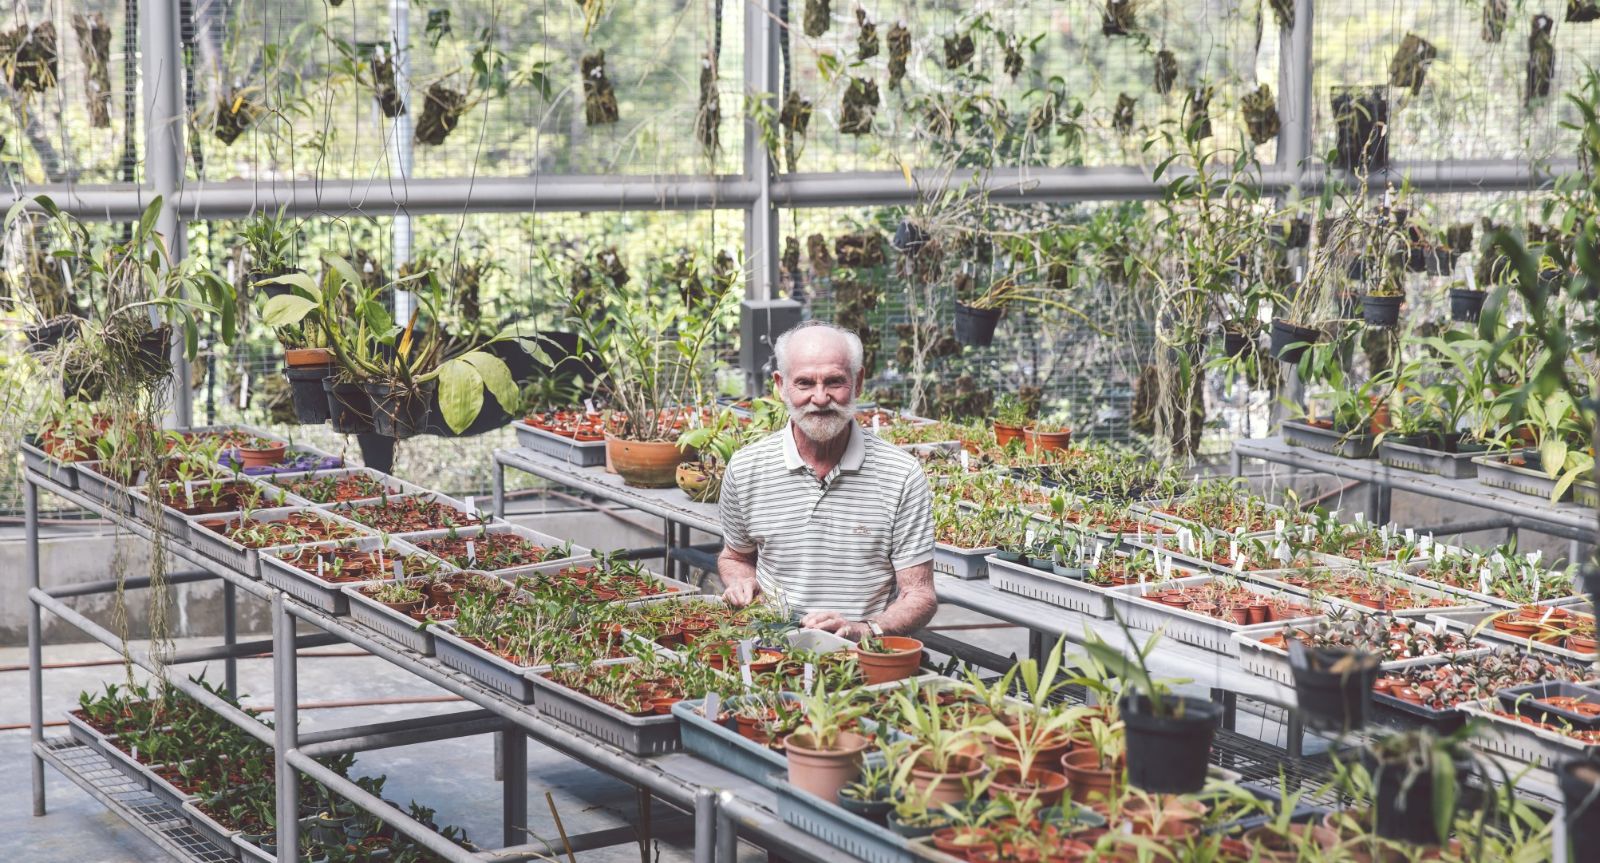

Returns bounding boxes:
[1083,624,1222,794]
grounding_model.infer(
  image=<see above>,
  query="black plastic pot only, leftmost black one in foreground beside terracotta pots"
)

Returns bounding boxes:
[1120,695,1222,794]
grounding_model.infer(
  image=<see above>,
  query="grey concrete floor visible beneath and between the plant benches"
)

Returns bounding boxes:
[0,608,1026,863]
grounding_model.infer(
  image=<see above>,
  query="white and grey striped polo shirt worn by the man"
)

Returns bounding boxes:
[722,423,933,620]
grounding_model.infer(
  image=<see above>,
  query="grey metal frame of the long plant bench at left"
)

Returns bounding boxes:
[24,461,837,863]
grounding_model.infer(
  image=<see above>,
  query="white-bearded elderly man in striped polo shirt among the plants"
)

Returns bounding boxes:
[717,320,939,640]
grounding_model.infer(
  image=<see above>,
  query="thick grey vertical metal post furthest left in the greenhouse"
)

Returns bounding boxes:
[139,0,194,427]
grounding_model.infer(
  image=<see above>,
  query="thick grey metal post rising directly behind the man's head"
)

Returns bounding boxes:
[744,0,778,299]
